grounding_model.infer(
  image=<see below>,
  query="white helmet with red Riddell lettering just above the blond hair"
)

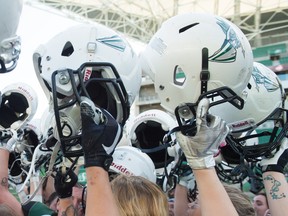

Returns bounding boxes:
[109,146,156,183]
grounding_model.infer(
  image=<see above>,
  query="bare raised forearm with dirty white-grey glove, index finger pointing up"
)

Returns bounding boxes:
[176,98,238,216]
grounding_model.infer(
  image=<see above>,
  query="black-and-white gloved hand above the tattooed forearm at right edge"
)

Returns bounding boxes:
[260,137,288,173]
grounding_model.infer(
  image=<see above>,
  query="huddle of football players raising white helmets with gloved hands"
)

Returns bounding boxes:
[0,0,288,216]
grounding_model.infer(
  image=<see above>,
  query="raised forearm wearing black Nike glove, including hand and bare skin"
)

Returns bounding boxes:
[80,98,122,216]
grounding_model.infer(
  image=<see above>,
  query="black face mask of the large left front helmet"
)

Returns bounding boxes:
[51,63,130,157]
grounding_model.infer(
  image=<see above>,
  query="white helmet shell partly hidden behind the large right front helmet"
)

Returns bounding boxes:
[209,62,285,134]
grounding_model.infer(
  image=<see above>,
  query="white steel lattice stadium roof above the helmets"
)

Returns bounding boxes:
[26,0,288,46]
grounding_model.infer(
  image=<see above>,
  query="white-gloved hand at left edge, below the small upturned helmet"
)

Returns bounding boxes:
[0,130,17,152]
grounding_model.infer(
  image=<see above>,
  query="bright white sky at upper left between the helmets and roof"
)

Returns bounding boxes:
[0,4,143,118]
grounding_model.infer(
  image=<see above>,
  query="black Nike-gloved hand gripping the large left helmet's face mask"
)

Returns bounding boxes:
[80,97,122,171]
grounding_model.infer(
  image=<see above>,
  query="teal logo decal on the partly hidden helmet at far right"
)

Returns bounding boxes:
[252,67,280,92]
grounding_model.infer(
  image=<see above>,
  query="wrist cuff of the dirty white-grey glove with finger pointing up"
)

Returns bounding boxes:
[187,155,215,170]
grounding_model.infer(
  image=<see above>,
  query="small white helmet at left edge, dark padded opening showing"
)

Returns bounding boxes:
[0,82,38,130]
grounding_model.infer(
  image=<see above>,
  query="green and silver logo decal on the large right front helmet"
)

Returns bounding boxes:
[209,19,245,63]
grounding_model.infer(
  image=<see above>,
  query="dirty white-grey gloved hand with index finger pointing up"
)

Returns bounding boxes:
[176,98,229,169]
